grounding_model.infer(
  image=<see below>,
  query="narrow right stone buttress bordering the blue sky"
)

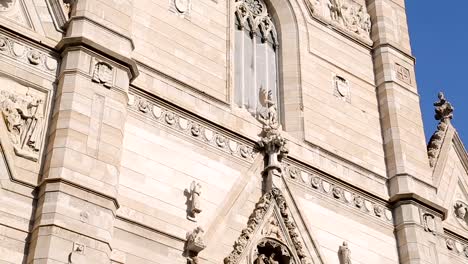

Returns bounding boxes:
[367,0,444,264]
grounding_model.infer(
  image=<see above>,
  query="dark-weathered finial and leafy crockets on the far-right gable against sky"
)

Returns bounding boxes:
[427,92,454,167]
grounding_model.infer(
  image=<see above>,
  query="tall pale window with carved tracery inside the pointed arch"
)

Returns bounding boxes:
[234,0,280,116]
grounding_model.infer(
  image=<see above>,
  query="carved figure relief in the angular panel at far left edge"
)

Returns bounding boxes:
[0,91,44,161]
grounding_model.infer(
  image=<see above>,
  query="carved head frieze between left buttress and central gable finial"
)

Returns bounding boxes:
[128,92,256,163]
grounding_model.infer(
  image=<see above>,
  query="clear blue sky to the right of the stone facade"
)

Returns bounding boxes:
[406,0,468,148]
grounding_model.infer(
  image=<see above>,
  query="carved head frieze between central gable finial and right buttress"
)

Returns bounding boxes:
[284,161,393,223]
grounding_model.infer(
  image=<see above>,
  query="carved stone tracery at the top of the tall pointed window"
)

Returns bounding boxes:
[234,0,278,46]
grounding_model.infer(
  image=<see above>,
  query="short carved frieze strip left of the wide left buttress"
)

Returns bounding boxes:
[0,34,58,77]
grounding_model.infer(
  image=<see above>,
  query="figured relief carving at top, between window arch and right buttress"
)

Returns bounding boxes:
[305,0,372,45]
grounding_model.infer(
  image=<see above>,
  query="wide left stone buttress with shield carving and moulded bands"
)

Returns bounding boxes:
[28,0,137,264]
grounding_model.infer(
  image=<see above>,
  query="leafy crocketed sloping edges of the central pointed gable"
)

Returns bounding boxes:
[224,188,310,264]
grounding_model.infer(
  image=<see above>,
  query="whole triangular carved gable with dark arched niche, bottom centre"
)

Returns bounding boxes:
[224,188,321,264]
